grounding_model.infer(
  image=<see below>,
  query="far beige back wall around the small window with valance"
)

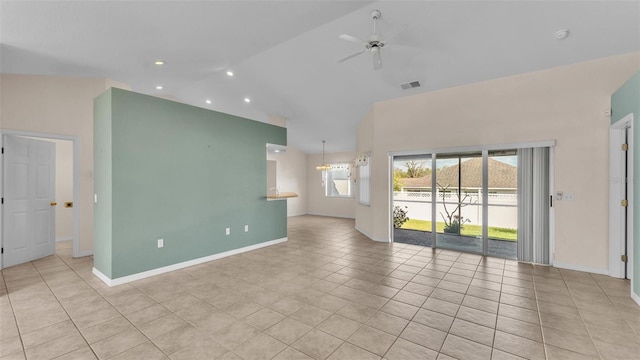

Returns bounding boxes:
[306,152,356,219]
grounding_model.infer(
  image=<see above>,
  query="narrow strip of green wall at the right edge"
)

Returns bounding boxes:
[611,71,640,297]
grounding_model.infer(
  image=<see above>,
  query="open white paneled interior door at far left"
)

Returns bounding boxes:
[2,135,56,267]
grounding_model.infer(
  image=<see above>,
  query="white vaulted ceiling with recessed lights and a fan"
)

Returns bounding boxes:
[0,0,640,153]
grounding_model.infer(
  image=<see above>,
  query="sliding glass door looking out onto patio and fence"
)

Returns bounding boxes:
[393,148,536,259]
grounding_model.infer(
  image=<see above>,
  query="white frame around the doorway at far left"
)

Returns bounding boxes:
[0,129,82,269]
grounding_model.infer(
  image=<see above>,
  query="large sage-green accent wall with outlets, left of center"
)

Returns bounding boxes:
[94,89,287,279]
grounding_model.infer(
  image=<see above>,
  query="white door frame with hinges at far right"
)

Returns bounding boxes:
[609,113,634,280]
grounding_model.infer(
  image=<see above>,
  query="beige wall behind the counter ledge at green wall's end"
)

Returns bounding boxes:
[267,146,307,216]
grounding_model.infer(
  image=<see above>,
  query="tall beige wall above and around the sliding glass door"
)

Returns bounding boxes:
[356,53,640,272]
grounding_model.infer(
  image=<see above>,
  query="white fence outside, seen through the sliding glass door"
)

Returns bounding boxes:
[393,191,518,229]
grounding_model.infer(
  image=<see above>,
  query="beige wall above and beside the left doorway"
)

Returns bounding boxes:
[0,74,122,254]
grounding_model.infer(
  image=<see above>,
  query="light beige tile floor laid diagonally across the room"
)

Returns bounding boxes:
[0,216,640,360]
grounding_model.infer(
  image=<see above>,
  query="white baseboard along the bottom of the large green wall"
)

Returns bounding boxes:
[93,237,288,286]
